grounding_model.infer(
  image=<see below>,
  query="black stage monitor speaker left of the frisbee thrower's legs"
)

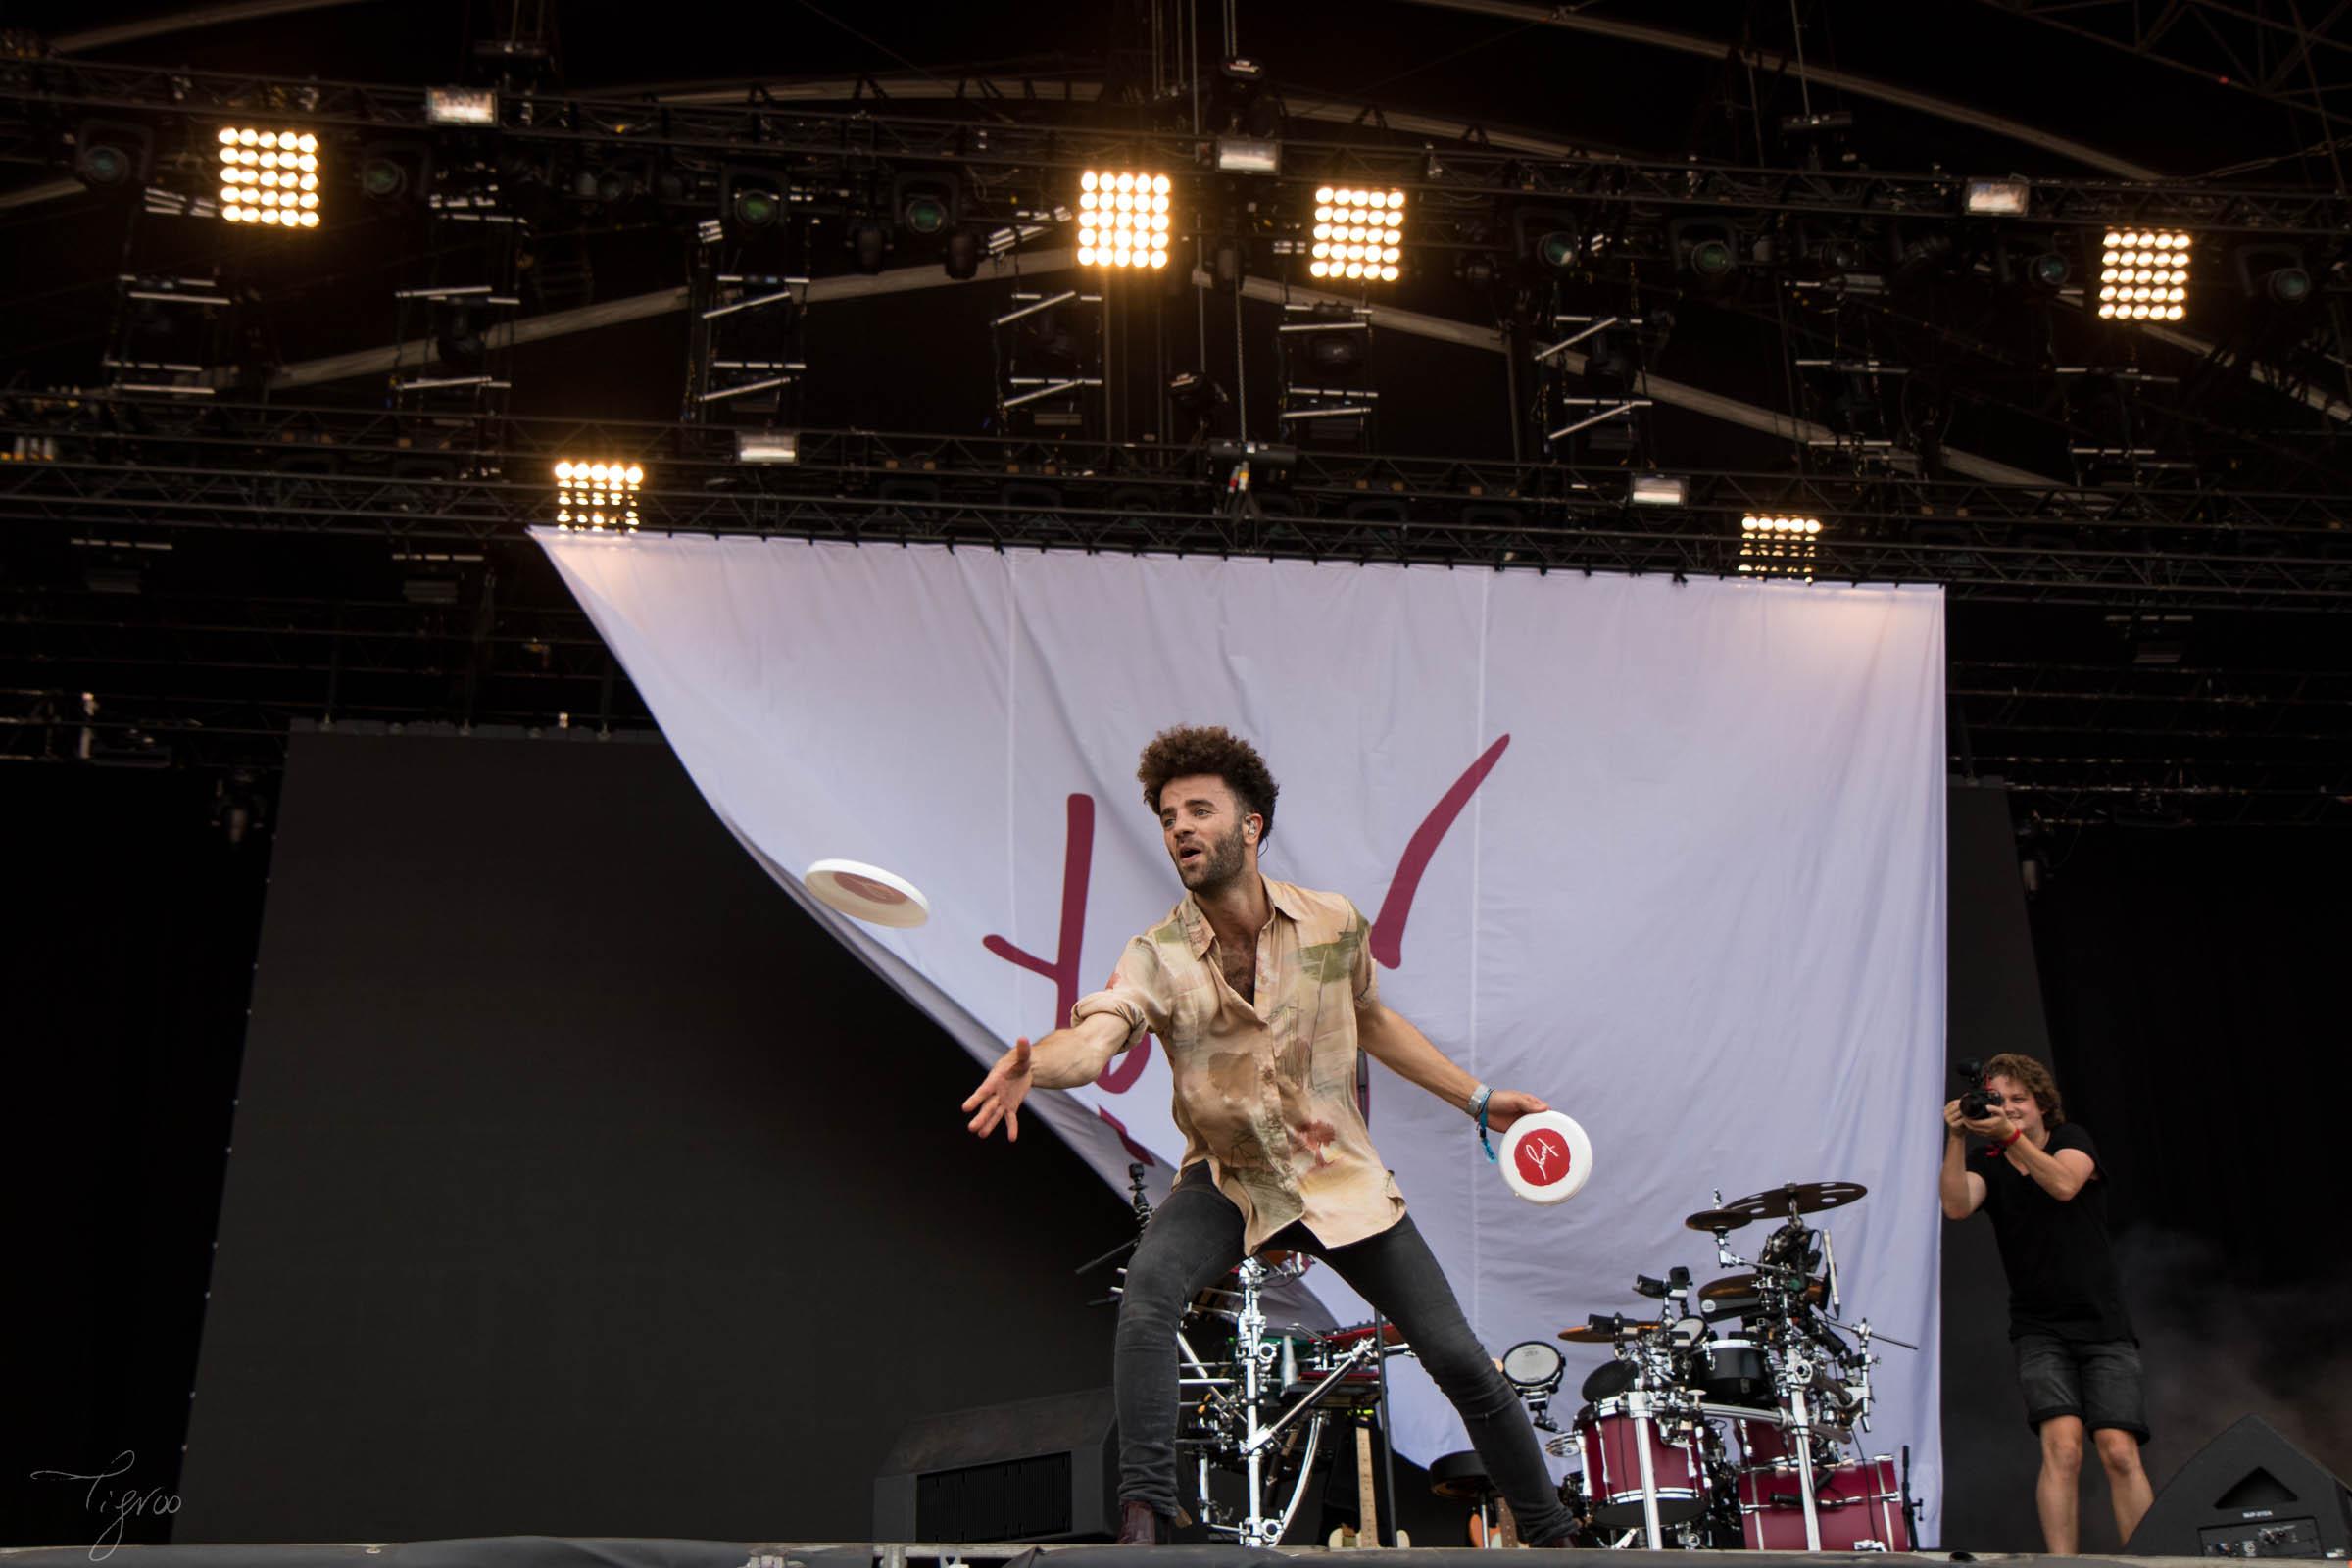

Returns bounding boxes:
[875,1390,1119,1543]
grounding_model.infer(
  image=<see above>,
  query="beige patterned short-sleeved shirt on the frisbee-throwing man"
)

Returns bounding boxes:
[1070,877,1404,1250]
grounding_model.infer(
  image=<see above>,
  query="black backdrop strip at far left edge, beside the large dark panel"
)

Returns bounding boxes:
[0,761,269,1544]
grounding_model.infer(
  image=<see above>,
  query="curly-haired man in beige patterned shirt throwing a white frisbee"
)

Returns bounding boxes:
[964,726,1571,1544]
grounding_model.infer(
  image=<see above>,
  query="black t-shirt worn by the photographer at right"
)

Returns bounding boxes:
[1969,1121,2135,1340]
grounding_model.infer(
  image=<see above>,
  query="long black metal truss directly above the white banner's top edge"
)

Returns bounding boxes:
[0,405,2352,612]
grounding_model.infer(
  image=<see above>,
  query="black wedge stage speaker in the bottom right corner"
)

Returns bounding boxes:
[2124,1415,2352,1556]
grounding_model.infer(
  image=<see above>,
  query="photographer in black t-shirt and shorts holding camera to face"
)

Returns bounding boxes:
[1940,1055,2150,1554]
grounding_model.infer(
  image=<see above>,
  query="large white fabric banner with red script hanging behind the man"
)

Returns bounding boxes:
[539,531,1945,1540]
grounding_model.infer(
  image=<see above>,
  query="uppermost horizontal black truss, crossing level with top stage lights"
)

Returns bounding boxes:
[0,59,2352,235]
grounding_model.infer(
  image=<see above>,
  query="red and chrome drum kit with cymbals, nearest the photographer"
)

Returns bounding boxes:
[1503,1183,1915,1551]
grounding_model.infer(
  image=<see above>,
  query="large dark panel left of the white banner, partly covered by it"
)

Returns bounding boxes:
[174,736,1131,1540]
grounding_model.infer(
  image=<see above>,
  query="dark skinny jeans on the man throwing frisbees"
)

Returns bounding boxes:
[1112,1163,1569,1543]
